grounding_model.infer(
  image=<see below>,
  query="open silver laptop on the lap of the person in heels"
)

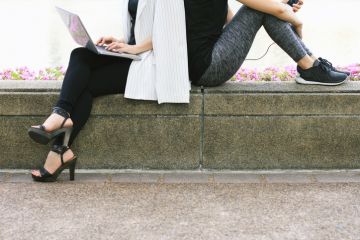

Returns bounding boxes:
[56,7,141,60]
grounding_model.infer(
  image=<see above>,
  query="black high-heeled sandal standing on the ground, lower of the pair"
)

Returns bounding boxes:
[31,145,77,182]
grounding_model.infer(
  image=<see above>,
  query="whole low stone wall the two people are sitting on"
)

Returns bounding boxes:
[0,81,360,170]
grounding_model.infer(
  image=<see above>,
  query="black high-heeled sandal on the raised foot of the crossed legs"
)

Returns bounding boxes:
[28,107,73,146]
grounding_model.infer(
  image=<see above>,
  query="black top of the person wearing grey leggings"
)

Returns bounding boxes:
[184,0,228,82]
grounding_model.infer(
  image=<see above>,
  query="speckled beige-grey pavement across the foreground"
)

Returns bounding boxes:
[0,183,360,240]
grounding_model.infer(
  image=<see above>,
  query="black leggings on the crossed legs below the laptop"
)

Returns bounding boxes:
[54,48,132,146]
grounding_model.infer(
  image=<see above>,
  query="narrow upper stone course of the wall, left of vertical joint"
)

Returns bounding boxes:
[0,92,202,116]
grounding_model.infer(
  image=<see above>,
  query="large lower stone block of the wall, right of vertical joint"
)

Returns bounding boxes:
[203,116,360,170]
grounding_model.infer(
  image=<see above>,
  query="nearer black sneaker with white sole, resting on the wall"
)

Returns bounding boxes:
[295,60,348,86]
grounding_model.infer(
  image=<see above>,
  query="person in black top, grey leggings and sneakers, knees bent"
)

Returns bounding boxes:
[184,0,349,87]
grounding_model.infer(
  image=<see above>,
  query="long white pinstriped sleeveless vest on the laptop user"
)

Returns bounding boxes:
[121,0,191,104]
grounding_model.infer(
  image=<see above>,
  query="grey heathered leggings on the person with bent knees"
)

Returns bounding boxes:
[196,6,312,87]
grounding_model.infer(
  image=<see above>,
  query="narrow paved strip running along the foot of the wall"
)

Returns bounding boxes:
[0,169,360,184]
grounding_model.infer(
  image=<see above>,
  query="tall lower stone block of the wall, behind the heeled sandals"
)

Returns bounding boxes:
[0,117,200,169]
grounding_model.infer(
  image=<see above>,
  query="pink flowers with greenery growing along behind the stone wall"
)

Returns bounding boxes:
[0,64,360,82]
